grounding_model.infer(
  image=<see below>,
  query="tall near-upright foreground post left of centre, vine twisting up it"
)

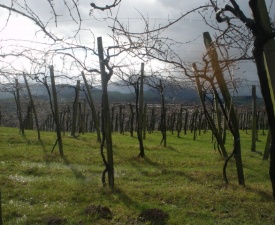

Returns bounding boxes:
[97,37,114,187]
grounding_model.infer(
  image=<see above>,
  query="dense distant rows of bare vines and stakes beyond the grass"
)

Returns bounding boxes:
[0,88,268,138]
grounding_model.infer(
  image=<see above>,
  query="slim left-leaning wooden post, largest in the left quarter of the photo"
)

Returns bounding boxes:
[50,66,64,157]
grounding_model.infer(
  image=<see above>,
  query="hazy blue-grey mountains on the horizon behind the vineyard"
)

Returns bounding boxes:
[0,83,263,105]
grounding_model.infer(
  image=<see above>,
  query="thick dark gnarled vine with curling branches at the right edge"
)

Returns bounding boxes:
[211,0,275,198]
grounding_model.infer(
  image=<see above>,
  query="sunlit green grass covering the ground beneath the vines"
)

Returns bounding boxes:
[0,127,275,225]
